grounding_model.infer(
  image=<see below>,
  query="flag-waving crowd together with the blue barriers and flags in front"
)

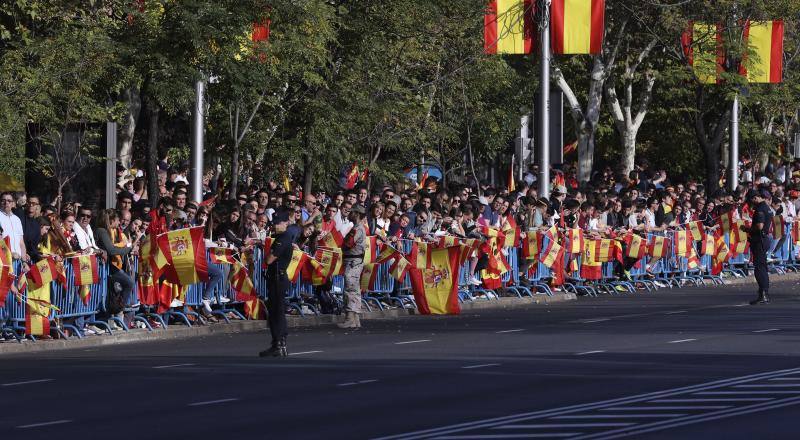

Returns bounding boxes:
[0,159,800,341]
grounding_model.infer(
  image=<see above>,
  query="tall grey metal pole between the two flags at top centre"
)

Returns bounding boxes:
[538,0,550,197]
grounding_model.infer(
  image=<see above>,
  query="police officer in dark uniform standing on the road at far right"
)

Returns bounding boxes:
[742,189,772,305]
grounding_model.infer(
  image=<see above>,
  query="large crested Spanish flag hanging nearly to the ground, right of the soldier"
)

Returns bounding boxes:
[409,247,461,315]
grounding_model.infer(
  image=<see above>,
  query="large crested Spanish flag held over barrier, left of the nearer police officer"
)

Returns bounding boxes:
[157,227,208,286]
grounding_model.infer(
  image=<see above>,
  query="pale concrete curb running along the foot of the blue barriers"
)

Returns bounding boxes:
[0,292,577,355]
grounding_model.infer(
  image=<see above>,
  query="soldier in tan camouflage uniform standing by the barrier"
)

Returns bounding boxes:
[339,205,367,329]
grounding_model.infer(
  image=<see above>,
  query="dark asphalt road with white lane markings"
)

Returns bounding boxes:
[0,282,800,440]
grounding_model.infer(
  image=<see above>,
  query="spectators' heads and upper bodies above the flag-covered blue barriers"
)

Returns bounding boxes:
[0,153,800,338]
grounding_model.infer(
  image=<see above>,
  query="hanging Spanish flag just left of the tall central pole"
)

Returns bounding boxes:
[483,0,534,55]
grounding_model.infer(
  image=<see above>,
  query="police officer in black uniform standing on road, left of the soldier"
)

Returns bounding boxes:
[258,211,292,357]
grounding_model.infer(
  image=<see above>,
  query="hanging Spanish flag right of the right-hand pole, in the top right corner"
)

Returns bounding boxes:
[740,21,783,83]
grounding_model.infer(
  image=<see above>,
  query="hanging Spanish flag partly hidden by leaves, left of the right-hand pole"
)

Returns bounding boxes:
[681,22,725,84]
